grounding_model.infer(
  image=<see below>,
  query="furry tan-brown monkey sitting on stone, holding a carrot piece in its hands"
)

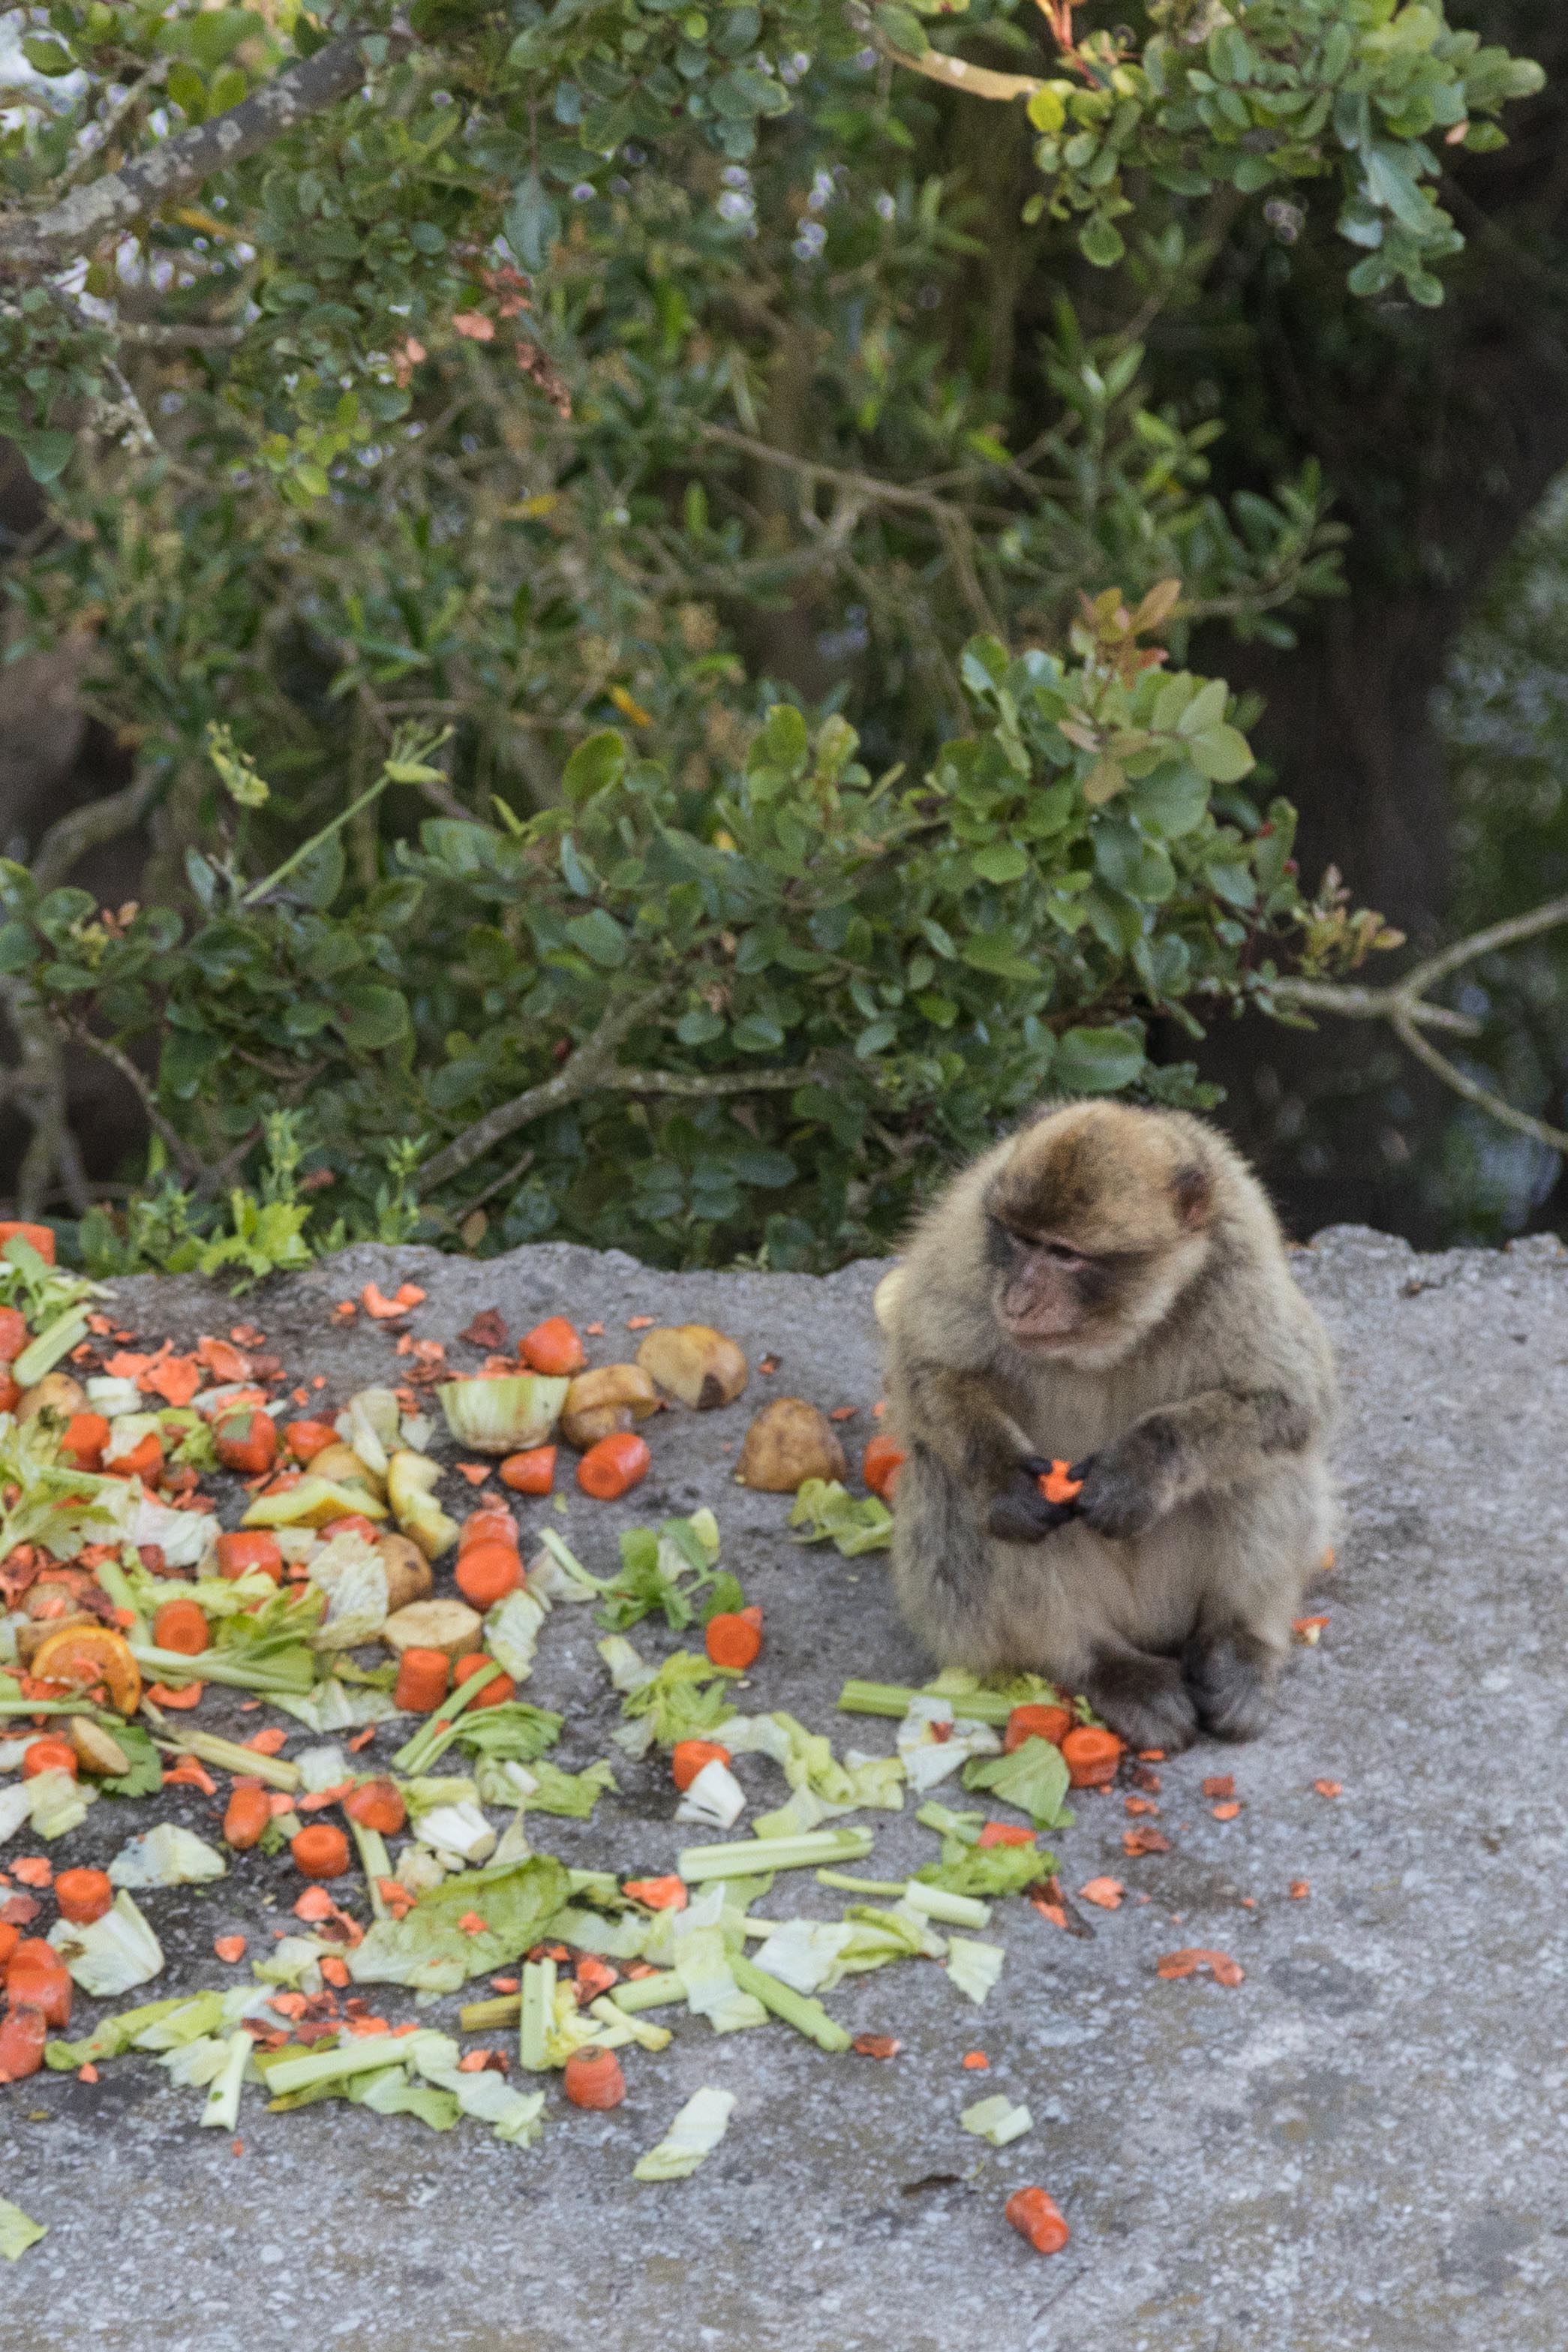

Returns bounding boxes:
[877,1101,1335,1753]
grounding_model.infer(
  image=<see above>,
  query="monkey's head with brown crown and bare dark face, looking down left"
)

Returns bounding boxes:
[985,1103,1211,1366]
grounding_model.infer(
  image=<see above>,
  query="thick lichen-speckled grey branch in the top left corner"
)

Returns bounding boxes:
[0,33,365,278]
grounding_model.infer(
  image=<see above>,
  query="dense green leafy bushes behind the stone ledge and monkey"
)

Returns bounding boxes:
[0,0,1537,1263]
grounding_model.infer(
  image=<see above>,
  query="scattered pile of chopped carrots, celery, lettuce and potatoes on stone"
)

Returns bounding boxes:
[0,1227,1203,2255]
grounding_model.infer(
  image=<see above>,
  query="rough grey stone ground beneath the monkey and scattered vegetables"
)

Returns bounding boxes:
[0,1227,1568,2352]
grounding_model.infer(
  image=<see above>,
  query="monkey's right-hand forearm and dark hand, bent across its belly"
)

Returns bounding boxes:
[1072,1388,1317,1536]
